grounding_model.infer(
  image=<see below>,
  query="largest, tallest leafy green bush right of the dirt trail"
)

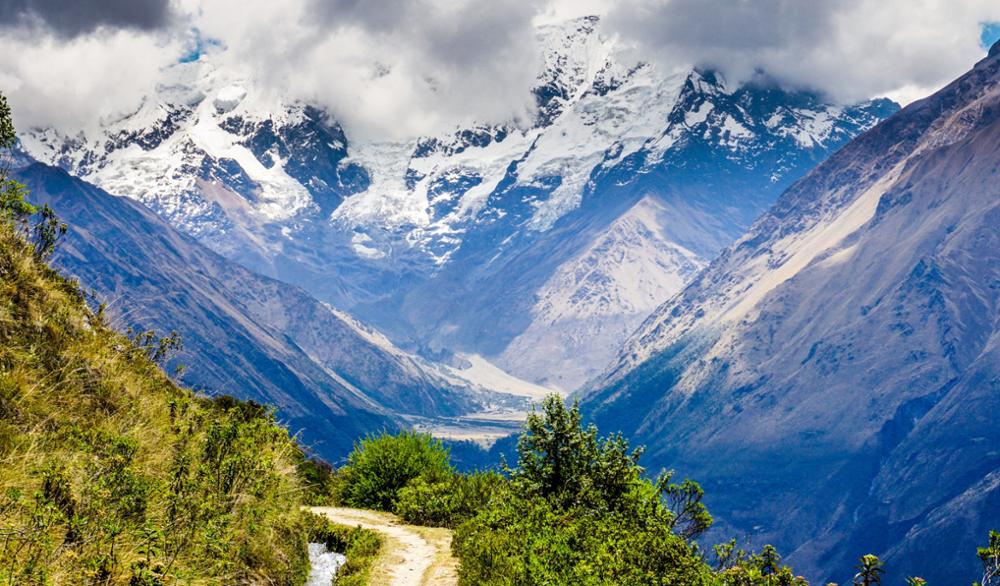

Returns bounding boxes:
[454,396,714,586]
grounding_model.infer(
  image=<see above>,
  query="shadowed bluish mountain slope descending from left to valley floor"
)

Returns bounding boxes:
[15,161,516,460]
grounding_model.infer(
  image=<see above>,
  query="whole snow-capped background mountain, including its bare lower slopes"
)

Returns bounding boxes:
[22,18,896,390]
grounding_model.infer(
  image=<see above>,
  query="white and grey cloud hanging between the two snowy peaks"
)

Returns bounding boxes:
[193,0,540,138]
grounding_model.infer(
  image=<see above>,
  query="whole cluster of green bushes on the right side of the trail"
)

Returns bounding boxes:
[337,397,804,586]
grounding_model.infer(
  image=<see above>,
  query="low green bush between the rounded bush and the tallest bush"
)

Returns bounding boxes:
[396,472,507,528]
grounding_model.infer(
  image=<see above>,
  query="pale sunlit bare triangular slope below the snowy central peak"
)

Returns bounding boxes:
[499,197,704,390]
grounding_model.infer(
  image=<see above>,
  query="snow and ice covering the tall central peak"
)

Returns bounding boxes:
[334,19,684,263]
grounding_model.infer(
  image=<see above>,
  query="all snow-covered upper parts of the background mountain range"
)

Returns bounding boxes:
[22,18,888,264]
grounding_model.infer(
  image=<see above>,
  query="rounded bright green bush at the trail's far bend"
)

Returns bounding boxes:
[341,431,454,511]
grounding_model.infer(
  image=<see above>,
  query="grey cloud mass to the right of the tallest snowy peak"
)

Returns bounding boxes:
[604,0,1000,102]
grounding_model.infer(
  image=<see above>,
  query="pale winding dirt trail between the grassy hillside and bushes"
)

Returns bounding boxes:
[312,507,458,586]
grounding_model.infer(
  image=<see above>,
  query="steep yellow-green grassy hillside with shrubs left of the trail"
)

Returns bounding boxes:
[0,92,322,586]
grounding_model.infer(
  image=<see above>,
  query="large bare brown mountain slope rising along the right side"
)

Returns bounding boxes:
[583,40,1000,584]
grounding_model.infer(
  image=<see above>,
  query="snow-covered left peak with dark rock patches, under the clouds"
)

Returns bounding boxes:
[22,54,364,251]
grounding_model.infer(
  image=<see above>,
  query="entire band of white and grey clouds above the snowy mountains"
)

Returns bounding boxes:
[0,0,1000,138]
